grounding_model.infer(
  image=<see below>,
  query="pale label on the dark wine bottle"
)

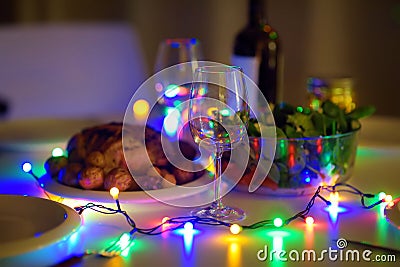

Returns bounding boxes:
[231,55,260,110]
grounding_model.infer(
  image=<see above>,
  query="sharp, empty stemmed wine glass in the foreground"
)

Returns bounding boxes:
[189,65,249,222]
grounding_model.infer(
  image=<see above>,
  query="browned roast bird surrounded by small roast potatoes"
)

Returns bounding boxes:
[45,123,204,191]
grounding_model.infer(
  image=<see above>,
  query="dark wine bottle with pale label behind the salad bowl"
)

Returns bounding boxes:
[231,0,279,107]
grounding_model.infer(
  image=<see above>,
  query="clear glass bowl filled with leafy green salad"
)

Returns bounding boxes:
[239,100,375,195]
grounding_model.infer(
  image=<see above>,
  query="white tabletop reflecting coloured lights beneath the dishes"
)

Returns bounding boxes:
[0,117,400,267]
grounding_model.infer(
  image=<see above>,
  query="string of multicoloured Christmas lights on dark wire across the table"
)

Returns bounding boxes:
[22,160,394,256]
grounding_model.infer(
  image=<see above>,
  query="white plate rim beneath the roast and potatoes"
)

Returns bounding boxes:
[40,174,212,203]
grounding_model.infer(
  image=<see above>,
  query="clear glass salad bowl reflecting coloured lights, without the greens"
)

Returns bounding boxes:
[237,129,359,196]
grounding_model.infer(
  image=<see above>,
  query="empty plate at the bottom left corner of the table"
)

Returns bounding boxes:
[0,195,81,266]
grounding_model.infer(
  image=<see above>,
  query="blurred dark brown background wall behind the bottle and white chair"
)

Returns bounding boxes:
[0,0,400,117]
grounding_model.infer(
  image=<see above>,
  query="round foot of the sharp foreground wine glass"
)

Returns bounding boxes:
[191,205,246,222]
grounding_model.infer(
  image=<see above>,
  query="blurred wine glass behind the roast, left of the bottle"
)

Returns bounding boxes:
[151,38,202,138]
